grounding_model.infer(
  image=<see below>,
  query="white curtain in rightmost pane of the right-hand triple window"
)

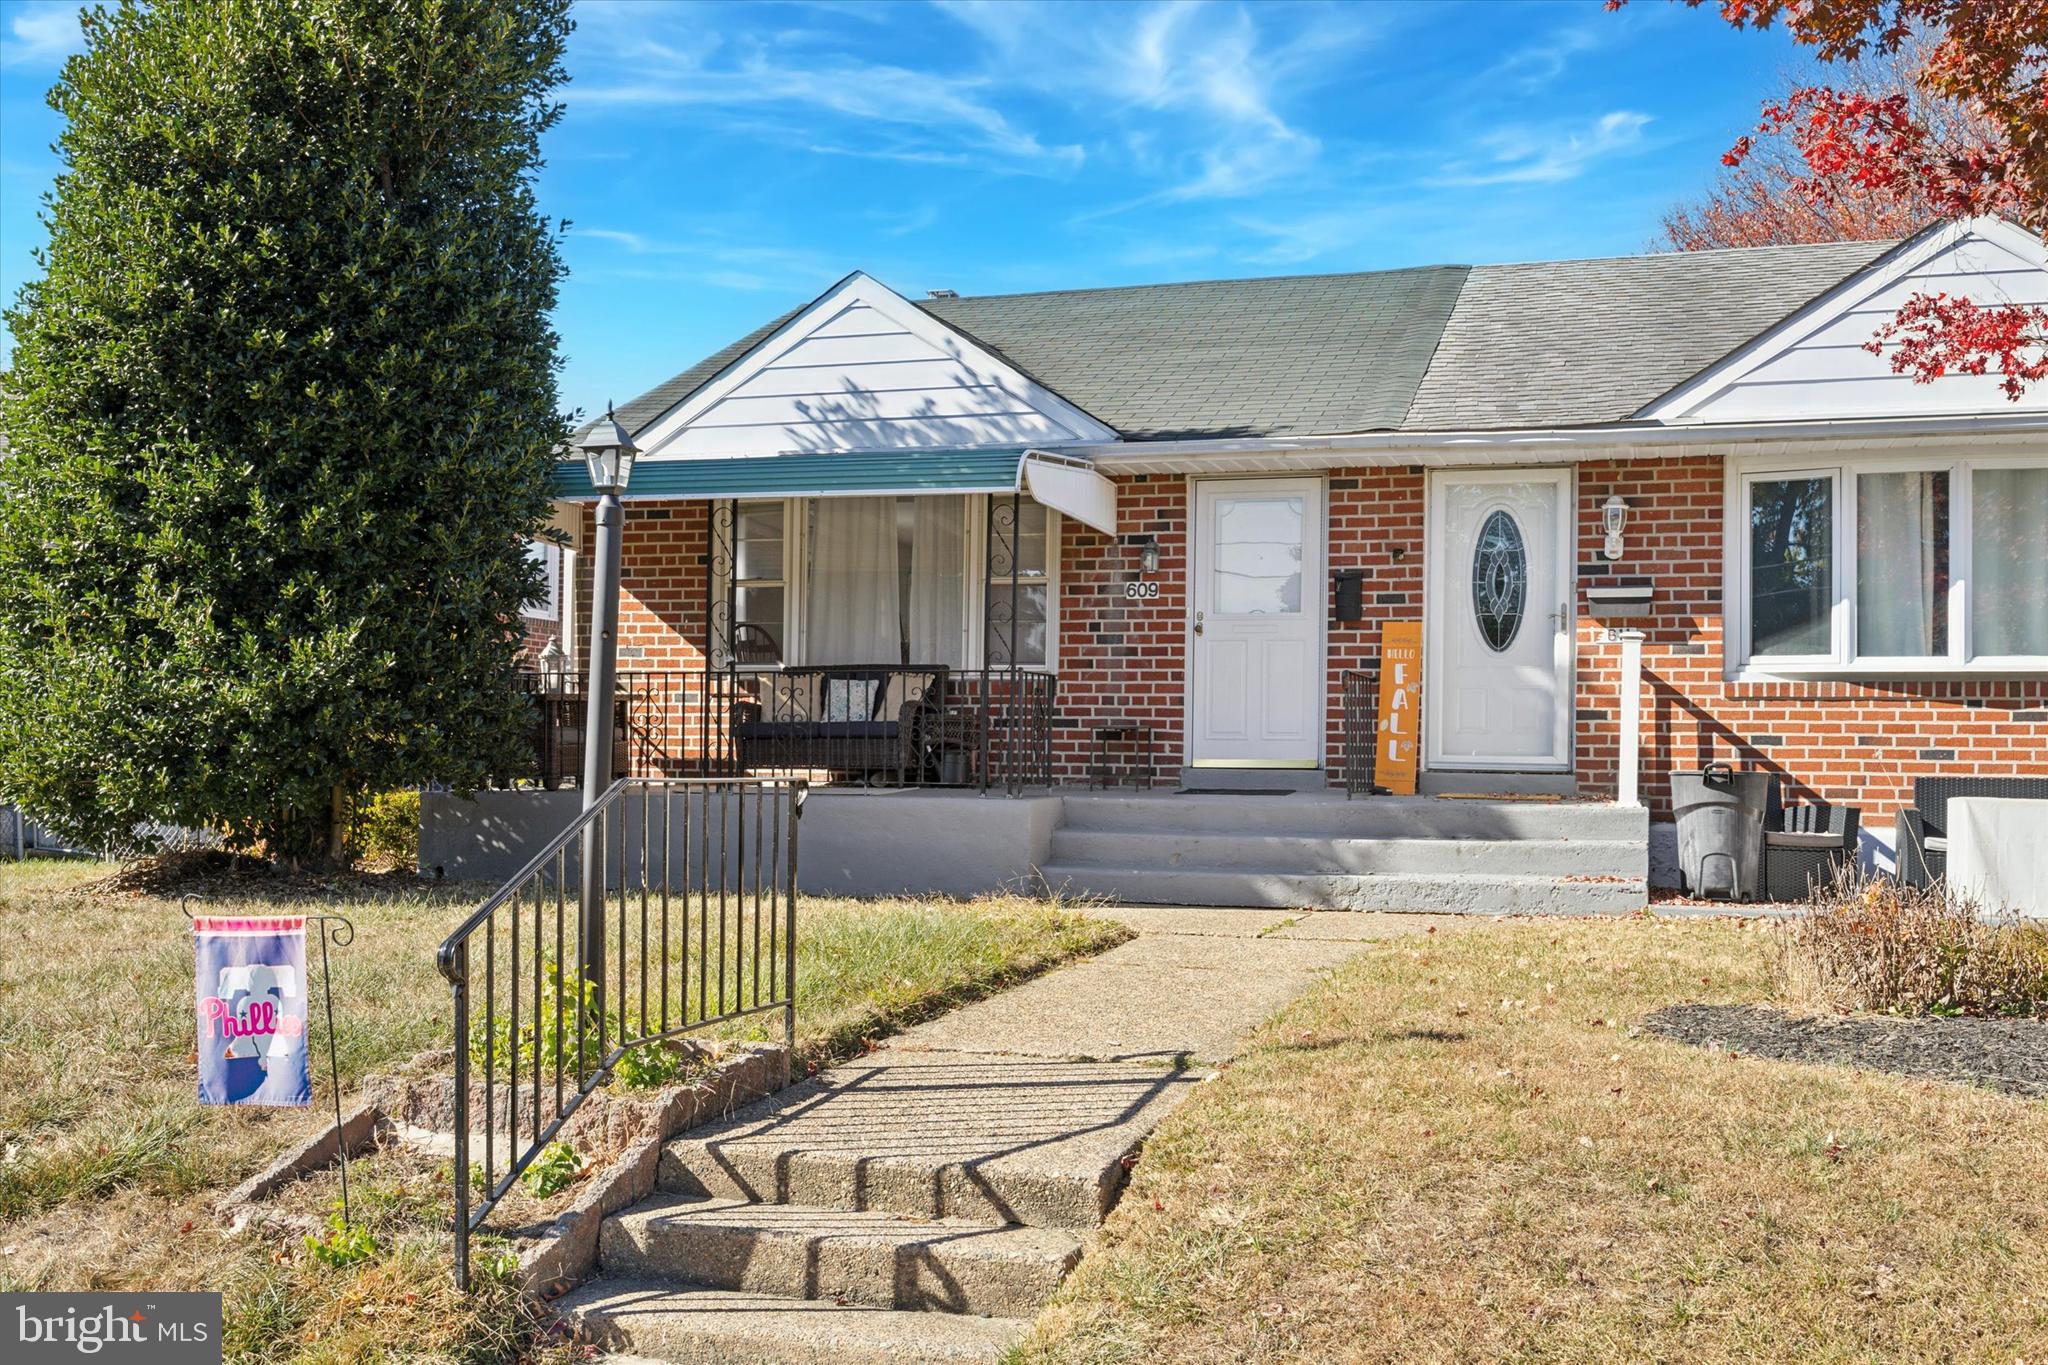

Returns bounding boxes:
[1970,467,2048,655]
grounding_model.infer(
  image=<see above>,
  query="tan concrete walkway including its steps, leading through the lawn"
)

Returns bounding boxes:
[557,907,1440,1365]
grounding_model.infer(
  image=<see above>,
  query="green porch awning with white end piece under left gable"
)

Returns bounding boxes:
[553,448,1116,534]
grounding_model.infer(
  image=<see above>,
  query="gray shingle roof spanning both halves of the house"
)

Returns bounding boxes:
[602,241,1896,440]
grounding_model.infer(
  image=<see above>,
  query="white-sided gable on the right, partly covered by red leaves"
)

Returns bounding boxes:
[1640,219,2048,424]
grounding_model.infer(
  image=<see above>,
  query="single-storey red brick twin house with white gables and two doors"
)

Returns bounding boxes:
[532,219,2048,900]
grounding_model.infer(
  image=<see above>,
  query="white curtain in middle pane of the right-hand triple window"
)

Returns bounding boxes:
[1855,471,1948,659]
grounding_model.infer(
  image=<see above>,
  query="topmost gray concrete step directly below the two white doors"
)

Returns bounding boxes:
[1061,792,1649,839]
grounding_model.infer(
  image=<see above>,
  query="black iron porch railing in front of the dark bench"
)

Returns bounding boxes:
[702,663,1059,792]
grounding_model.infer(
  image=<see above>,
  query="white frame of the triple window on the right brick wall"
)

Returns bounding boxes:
[1720,450,2048,681]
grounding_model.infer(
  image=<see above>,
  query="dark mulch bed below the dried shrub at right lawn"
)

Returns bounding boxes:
[1642,1005,2048,1099]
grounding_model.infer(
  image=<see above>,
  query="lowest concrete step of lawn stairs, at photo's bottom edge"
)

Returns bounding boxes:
[553,1277,1030,1365]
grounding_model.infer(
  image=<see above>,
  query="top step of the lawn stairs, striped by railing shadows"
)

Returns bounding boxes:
[657,1054,1200,1230]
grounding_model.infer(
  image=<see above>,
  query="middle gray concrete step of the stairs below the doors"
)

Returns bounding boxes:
[1049,829,1649,880]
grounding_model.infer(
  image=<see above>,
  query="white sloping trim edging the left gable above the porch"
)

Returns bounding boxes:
[635,270,1116,460]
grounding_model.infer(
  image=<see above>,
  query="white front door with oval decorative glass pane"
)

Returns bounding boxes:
[1421,469,1573,772]
